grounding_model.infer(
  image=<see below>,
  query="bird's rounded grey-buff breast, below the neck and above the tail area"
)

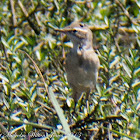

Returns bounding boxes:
[65,51,98,87]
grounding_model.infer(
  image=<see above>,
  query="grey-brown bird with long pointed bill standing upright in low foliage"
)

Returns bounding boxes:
[57,22,100,103]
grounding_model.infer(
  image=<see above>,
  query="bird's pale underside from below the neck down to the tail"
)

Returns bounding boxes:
[65,50,99,101]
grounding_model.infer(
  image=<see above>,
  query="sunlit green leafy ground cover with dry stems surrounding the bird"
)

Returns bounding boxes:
[0,0,140,140]
